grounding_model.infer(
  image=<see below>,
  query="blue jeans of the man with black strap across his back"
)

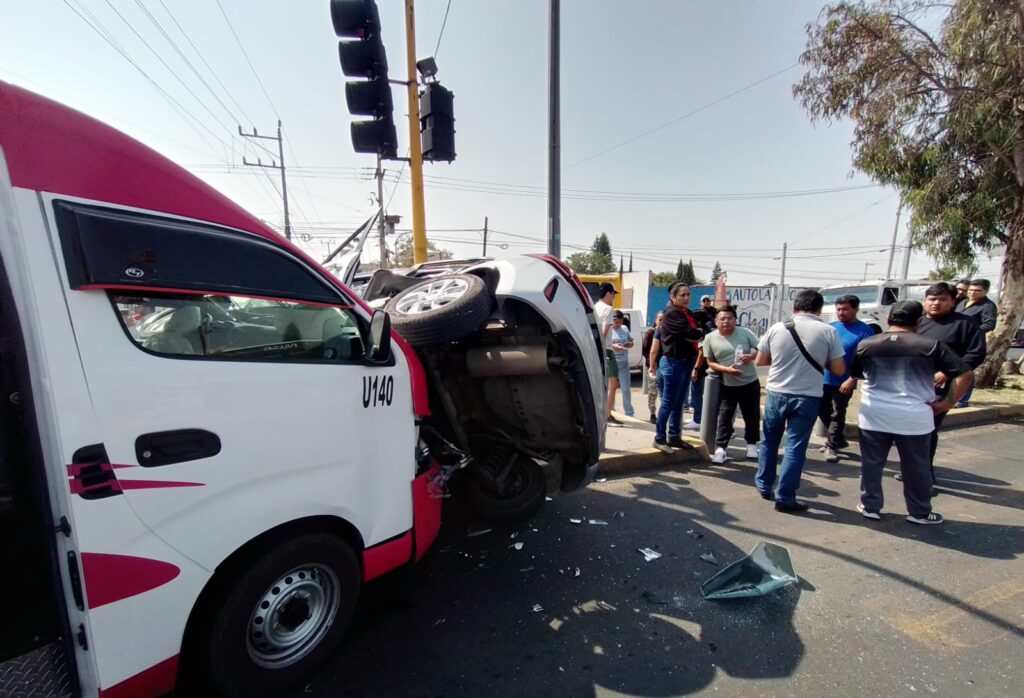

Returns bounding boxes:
[754,392,821,505]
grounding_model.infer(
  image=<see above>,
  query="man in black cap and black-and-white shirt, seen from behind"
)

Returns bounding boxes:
[850,301,971,524]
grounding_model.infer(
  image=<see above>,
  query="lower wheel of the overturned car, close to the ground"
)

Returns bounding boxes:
[467,447,548,526]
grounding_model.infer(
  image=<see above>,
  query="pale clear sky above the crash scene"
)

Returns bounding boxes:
[0,0,999,286]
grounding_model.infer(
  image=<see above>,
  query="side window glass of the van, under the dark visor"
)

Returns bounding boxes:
[111,293,364,363]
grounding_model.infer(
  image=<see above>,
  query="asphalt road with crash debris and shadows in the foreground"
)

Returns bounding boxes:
[294,423,1024,698]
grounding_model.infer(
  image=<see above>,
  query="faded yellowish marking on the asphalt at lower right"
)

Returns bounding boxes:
[865,579,1024,656]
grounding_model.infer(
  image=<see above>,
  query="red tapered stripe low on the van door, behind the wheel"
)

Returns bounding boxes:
[82,553,181,610]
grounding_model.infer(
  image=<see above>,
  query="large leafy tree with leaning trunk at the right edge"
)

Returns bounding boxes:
[794,0,1024,386]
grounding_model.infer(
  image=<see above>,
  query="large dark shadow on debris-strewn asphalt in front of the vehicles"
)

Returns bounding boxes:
[293,478,814,696]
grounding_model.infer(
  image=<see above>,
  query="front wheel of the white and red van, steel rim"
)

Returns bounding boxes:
[204,533,361,698]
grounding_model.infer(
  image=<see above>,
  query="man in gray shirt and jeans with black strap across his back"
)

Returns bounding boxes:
[754,290,846,514]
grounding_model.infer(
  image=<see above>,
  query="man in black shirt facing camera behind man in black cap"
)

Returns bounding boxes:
[918,282,986,478]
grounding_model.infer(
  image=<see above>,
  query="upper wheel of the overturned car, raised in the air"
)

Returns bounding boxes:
[385,274,490,347]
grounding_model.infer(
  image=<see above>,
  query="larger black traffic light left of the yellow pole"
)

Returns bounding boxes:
[331,0,398,159]
